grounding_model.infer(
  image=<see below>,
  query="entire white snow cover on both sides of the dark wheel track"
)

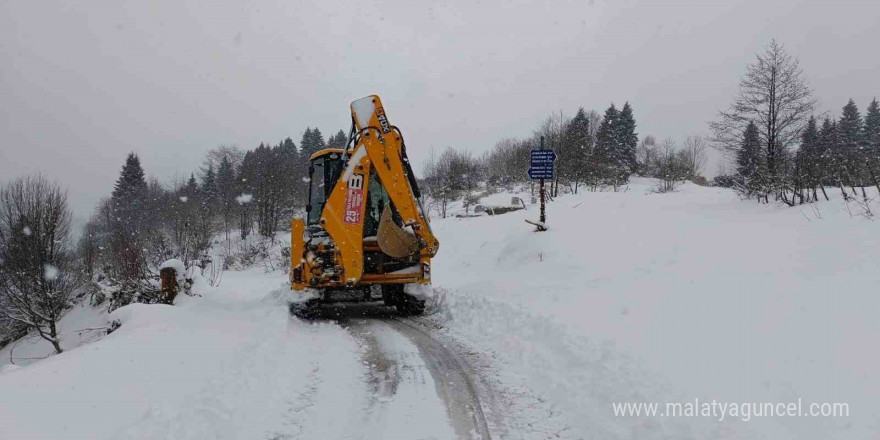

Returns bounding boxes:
[0,179,880,439]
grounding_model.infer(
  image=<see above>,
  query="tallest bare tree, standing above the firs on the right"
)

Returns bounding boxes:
[709,40,816,198]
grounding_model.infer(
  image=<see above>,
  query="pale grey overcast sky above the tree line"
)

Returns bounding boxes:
[0,0,880,216]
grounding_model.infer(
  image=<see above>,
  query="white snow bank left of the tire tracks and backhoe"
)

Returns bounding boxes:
[0,269,366,439]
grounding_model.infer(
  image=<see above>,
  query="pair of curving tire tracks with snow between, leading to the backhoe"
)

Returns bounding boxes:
[331,305,491,440]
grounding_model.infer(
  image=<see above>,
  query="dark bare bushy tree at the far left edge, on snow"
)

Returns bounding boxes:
[0,176,80,353]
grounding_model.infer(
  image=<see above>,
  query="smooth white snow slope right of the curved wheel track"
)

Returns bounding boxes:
[432,179,880,439]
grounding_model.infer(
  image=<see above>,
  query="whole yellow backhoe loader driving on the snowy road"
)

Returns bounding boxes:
[290,95,439,316]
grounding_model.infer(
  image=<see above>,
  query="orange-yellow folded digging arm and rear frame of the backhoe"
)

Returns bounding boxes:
[291,95,439,288]
